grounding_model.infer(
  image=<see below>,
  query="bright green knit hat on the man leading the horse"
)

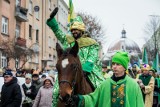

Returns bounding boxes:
[112,51,129,69]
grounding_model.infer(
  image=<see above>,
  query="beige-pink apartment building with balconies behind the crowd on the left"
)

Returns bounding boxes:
[0,0,68,70]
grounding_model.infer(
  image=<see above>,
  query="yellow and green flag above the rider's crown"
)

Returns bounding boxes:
[68,0,76,23]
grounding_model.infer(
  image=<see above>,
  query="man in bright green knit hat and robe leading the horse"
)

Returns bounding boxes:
[73,51,144,107]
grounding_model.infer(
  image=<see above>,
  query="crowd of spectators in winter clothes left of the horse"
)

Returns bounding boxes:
[0,69,54,107]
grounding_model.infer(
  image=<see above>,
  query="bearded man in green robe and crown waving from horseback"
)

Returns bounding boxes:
[46,8,104,107]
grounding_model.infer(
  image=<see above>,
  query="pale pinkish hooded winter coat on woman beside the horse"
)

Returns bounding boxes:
[33,77,53,107]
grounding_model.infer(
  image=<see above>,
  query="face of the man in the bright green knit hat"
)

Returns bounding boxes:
[112,63,125,77]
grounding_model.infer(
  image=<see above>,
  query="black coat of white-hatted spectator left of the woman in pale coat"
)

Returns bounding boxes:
[22,83,37,100]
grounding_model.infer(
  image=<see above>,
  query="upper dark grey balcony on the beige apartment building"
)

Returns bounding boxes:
[15,6,28,22]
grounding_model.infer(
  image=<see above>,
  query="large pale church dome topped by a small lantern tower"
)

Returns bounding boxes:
[107,29,141,55]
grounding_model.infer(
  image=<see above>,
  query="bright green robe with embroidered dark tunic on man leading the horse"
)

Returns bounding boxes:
[79,75,144,107]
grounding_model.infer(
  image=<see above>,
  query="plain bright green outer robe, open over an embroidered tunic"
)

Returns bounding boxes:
[79,75,144,107]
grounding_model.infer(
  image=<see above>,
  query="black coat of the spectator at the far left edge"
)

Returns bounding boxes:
[1,77,22,107]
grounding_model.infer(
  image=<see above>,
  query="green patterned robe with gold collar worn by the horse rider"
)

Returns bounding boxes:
[47,18,104,107]
